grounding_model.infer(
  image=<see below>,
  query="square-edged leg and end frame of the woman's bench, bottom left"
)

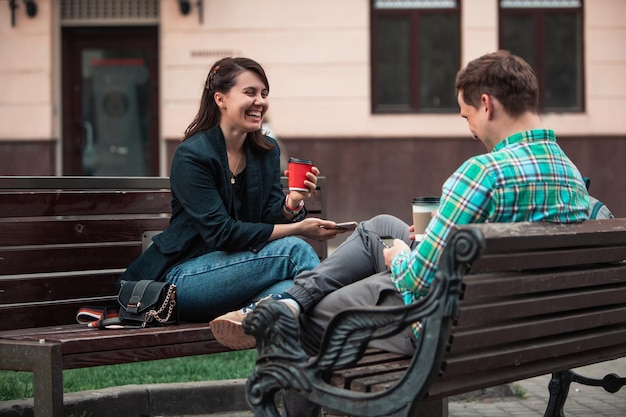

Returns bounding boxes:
[0,341,63,417]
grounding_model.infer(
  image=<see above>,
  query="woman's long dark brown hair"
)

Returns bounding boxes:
[183,57,274,151]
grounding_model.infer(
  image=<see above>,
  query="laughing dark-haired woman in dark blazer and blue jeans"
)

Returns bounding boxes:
[120,57,338,321]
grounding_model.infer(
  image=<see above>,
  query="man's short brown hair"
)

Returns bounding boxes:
[455,50,539,116]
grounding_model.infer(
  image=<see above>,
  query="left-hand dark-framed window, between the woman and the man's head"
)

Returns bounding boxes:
[371,0,460,113]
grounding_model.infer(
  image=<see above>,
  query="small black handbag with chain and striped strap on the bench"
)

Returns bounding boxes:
[76,279,178,329]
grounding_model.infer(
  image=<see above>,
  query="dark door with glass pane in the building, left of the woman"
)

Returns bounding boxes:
[62,27,159,176]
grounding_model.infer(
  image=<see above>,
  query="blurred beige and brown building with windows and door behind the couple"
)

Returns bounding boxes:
[0,0,626,221]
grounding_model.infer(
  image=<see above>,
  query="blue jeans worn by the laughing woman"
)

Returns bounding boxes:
[165,236,320,322]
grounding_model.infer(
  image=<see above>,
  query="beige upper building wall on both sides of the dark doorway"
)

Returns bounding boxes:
[0,0,626,174]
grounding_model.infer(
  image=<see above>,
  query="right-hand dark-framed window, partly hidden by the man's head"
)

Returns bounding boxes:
[500,0,584,112]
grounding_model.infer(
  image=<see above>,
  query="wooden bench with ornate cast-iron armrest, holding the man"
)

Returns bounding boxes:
[244,219,626,417]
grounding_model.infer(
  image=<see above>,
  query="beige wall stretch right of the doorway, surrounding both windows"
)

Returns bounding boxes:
[162,0,626,144]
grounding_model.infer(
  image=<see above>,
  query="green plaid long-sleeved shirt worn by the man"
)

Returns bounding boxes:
[391,129,590,334]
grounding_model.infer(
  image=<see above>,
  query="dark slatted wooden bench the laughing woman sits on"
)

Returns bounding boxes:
[0,177,326,417]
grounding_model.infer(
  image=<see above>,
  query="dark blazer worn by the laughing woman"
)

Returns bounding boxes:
[118,127,306,285]
